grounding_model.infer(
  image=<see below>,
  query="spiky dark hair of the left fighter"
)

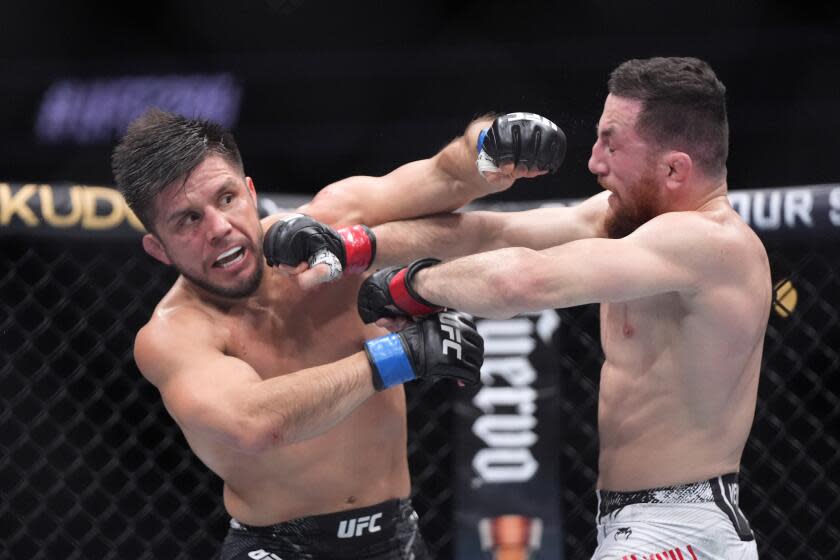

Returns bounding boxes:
[111,109,245,231]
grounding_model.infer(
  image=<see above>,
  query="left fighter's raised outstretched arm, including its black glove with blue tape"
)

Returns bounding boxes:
[300,113,566,227]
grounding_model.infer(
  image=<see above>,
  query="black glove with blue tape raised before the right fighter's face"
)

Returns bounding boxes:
[476,113,566,173]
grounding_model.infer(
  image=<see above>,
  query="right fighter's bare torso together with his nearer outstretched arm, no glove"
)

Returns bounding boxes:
[414,202,770,490]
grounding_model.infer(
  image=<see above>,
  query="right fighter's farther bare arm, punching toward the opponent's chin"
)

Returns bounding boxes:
[372,192,609,269]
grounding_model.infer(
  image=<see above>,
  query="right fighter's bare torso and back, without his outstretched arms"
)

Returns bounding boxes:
[598,204,770,490]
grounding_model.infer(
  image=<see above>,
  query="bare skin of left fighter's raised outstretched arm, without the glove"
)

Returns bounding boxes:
[298,118,502,227]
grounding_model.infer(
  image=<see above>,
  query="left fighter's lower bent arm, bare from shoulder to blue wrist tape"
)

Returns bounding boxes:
[135,311,375,453]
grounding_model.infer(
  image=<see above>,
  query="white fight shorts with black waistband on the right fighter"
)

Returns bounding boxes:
[592,474,758,560]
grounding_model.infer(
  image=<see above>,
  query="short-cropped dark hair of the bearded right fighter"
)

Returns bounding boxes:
[608,57,729,177]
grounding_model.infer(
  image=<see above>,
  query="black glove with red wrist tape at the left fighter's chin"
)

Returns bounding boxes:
[263,214,376,279]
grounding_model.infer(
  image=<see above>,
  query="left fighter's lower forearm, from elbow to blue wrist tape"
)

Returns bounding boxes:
[247,352,375,448]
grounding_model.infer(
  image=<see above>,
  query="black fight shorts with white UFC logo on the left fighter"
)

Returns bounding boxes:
[221,499,431,560]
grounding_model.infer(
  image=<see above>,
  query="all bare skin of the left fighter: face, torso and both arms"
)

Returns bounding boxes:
[134,117,533,525]
